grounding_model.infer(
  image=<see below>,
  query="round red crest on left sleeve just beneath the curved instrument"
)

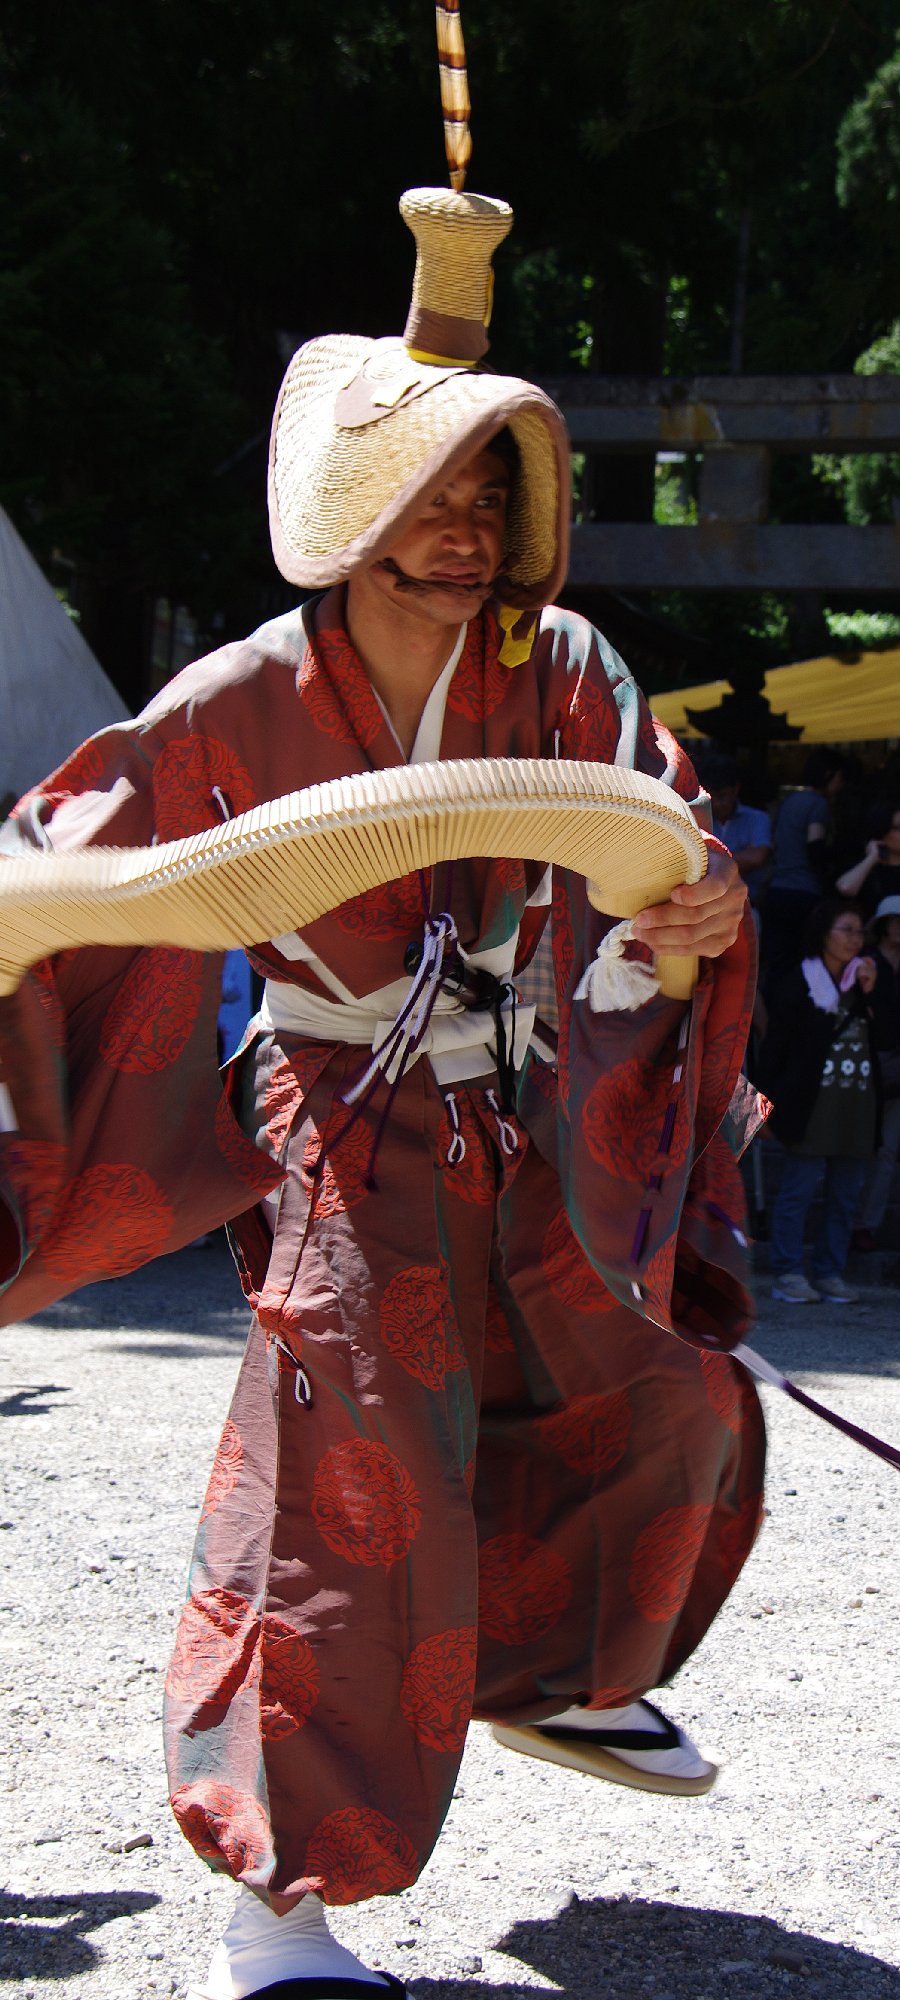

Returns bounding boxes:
[100,946,204,1076]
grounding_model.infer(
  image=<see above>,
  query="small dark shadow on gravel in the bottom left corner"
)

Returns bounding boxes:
[0,1890,160,1980]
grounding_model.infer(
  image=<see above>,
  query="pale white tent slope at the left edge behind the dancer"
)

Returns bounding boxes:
[0,508,128,800]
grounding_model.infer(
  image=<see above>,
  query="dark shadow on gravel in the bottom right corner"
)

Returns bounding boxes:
[414,1898,900,2000]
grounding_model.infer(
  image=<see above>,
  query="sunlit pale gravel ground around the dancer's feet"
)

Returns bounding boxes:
[0,1240,900,2000]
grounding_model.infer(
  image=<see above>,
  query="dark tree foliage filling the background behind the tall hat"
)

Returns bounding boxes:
[0,0,900,696]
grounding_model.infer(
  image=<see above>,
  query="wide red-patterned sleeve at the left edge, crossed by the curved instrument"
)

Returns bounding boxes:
[0,656,288,1324]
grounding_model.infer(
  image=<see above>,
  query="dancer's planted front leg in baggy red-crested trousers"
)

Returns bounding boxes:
[168,1066,494,2000]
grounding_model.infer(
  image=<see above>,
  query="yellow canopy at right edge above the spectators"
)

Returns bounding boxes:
[650,646,900,744]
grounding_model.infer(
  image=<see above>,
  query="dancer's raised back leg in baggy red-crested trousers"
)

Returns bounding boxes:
[474,1148,764,1790]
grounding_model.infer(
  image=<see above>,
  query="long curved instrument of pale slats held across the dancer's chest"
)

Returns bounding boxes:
[0,758,706,998]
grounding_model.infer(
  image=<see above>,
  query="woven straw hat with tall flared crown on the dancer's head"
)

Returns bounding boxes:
[268,188,570,608]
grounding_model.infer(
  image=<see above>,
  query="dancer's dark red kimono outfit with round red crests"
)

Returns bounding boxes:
[0,592,764,1902]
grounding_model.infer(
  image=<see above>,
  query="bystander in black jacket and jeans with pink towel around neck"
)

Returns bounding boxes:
[760,900,880,1304]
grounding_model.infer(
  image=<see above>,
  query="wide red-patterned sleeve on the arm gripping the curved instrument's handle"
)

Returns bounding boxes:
[524,610,764,1348]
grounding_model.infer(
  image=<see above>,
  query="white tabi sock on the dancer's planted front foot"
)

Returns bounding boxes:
[192,1888,382,2000]
